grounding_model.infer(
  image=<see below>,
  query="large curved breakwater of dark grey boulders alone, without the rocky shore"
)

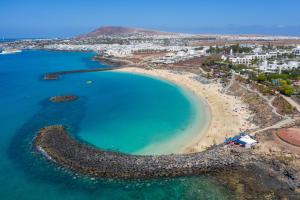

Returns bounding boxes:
[35,126,244,179]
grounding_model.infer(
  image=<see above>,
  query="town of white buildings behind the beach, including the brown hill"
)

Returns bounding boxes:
[0,27,300,98]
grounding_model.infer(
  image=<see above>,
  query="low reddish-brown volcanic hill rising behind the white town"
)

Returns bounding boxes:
[79,26,170,38]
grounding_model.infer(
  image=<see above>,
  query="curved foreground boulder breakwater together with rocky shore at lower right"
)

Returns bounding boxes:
[35,125,300,199]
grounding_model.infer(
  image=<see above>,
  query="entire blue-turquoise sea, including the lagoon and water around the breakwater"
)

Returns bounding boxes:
[0,51,231,199]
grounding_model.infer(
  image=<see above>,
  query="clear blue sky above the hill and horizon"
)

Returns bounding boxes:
[0,0,300,38]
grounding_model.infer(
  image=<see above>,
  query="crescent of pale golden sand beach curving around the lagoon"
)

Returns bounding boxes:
[117,67,256,153]
